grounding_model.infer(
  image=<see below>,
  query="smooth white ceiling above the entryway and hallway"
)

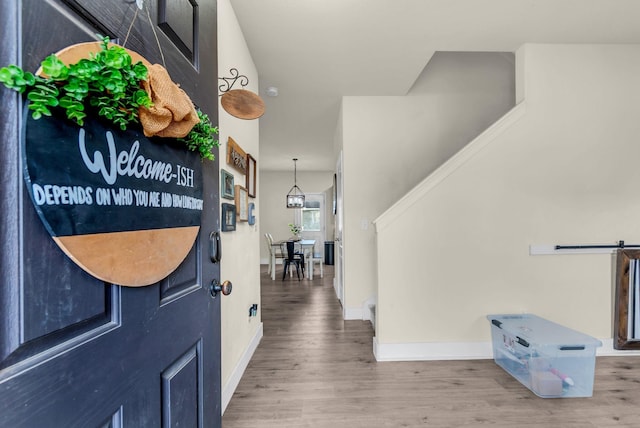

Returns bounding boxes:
[230,0,640,171]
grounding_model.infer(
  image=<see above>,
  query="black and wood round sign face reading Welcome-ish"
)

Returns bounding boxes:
[23,110,203,286]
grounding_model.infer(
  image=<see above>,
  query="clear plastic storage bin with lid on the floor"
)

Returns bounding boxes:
[487,314,602,398]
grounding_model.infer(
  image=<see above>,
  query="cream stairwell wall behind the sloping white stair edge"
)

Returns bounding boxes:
[336,53,515,317]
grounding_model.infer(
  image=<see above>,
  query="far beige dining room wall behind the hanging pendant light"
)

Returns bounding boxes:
[257,169,333,264]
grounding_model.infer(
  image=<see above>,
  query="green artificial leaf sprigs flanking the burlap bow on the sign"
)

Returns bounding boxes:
[0,37,218,160]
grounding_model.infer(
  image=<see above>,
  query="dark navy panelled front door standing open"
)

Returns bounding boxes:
[0,0,221,428]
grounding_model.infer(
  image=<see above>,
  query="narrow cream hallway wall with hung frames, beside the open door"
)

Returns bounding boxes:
[218,0,262,409]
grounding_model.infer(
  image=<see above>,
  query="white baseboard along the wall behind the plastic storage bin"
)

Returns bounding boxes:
[373,337,640,361]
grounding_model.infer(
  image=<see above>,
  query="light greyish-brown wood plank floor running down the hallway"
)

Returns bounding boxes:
[223,266,640,428]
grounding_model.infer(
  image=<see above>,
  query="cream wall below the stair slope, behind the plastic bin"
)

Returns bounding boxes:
[376,45,640,357]
